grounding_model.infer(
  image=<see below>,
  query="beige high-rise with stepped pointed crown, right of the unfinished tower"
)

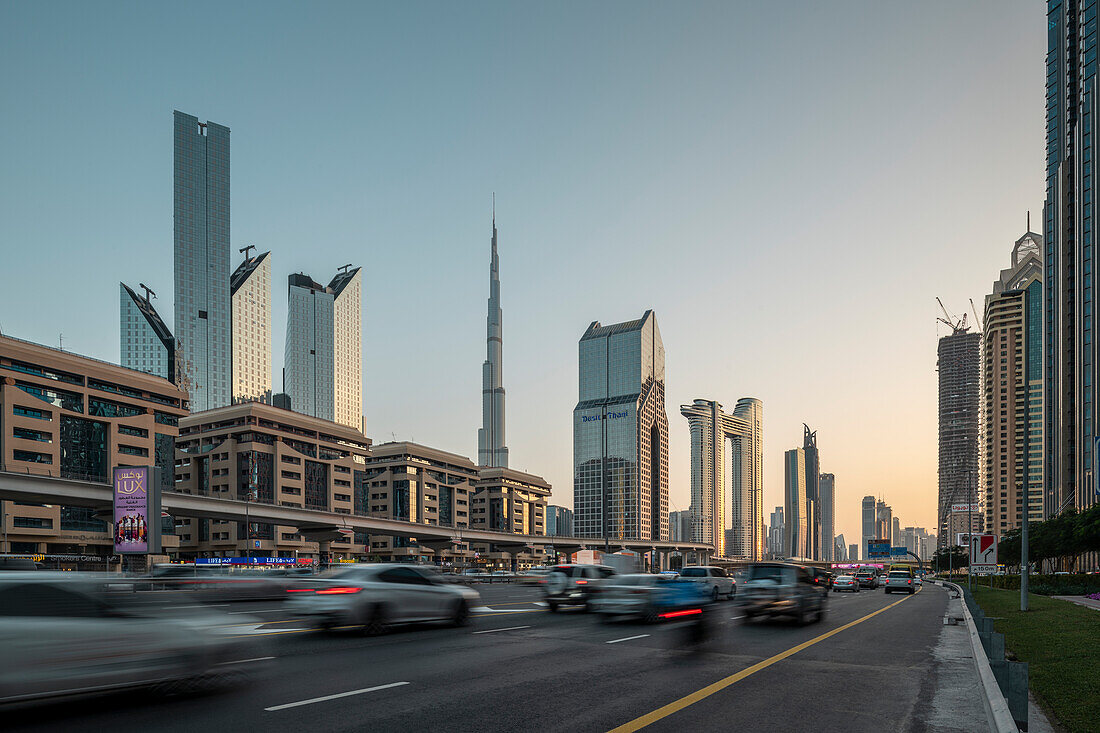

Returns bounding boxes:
[982,222,1043,536]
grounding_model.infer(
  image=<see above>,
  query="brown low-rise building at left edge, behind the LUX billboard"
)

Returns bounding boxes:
[0,336,188,569]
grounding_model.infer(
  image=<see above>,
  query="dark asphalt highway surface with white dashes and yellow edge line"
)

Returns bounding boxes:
[0,583,963,733]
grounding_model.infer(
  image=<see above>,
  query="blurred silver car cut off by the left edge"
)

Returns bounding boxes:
[0,572,270,702]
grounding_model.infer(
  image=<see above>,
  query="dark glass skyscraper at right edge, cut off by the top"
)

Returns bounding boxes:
[1038,0,1100,526]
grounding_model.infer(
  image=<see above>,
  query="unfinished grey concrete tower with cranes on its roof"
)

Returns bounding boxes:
[936,327,981,545]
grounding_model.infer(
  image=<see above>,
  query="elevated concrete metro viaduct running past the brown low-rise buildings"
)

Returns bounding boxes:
[0,470,714,565]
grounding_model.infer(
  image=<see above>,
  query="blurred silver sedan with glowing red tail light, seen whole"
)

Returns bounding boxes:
[286,564,481,634]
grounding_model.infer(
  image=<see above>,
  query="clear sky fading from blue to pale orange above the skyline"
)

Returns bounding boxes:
[0,0,1046,543]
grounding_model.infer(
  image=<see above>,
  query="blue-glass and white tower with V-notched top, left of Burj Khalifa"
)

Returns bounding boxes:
[283,265,363,430]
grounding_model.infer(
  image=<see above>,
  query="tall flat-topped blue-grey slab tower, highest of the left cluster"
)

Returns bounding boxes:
[173,111,233,413]
